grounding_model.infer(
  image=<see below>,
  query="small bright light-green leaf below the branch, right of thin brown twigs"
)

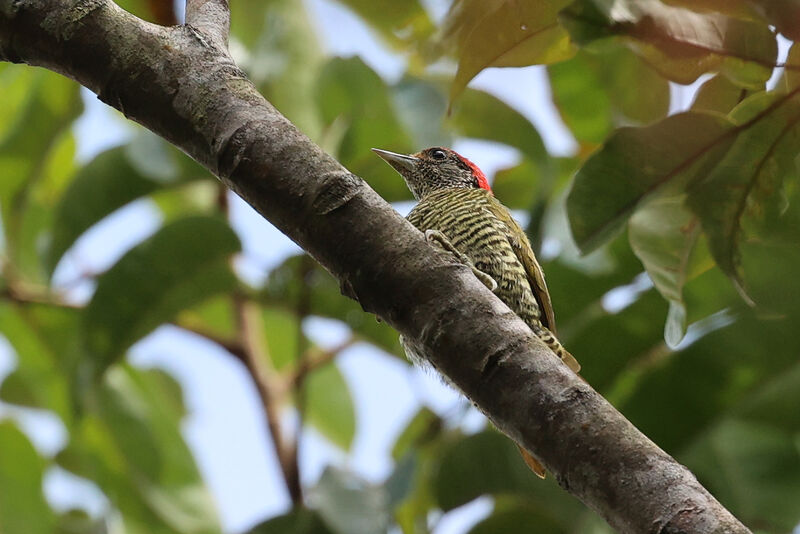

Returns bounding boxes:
[305,363,356,451]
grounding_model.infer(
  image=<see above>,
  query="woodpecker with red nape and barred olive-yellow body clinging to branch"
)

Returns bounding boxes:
[372,147,580,477]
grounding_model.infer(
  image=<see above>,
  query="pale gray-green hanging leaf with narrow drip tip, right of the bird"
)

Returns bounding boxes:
[628,195,713,348]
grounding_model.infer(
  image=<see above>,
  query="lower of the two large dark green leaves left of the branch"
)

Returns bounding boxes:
[82,217,240,372]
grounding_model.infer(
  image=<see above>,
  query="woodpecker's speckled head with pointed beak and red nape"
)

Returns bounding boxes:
[372,147,492,200]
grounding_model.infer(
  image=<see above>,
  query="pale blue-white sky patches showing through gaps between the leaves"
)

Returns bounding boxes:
[0,0,785,534]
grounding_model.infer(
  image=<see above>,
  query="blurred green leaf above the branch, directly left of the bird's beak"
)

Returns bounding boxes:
[317,57,413,202]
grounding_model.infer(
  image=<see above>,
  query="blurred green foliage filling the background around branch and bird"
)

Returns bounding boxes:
[0,0,800,534]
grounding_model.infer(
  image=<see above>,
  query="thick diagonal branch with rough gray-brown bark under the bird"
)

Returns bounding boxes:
[0,0,749,533]
